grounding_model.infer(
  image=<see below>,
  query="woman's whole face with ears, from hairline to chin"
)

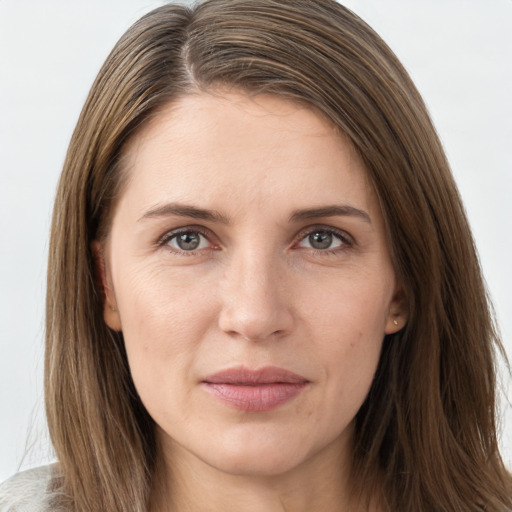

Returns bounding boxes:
[100,93,403,475]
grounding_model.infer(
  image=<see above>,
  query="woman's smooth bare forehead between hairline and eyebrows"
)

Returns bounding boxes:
[118,89,374,220]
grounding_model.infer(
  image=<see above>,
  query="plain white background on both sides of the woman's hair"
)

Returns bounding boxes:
[0,0,512,481]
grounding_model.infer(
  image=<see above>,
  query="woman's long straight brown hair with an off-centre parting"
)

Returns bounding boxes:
[45,0,512,512]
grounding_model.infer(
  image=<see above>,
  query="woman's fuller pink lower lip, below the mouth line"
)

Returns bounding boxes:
[205,382,307,412]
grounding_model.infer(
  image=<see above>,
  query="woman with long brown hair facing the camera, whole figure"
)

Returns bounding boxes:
[0,0,512,511]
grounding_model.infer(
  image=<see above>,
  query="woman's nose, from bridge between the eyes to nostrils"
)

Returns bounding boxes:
[219,251,294,341]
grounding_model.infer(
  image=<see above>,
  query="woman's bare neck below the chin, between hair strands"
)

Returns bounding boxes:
[150,428,376,512]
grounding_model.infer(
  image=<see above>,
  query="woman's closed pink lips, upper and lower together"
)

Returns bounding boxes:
[202,366,309,412]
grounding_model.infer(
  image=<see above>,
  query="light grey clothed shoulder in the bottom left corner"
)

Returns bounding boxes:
[0,464,58,512]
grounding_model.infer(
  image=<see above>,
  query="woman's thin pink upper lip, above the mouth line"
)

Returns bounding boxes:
[203,366,308,385]
